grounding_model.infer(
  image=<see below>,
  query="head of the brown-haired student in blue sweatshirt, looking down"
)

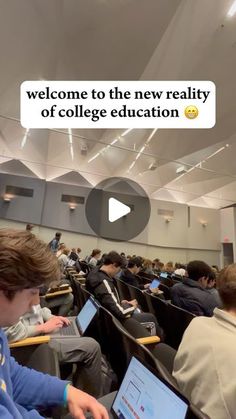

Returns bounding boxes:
[0,229,60,327]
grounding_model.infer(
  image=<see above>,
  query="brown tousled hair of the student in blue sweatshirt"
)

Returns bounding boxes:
[0,229,60,300]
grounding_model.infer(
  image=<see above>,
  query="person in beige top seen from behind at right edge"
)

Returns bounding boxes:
[173,264,236,419]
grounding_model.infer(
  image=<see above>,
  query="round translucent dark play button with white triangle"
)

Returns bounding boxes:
[85,177,151,241]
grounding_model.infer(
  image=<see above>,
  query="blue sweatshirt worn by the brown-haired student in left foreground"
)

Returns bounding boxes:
[0,329,68,419]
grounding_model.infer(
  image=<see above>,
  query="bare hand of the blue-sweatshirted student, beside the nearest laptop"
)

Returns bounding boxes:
[67,385,109,419]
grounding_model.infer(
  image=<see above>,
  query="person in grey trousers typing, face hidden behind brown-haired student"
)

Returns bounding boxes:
[4,306,101,397]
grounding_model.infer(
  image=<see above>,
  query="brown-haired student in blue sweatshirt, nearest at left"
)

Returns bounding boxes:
[0,229,108,419]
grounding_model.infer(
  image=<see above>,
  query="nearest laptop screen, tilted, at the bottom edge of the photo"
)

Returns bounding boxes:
[112,357,188,419]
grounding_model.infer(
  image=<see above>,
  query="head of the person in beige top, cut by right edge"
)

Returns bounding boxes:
[216,263,236,314]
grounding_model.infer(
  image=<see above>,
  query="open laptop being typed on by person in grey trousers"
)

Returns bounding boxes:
[50,297,98,339]
